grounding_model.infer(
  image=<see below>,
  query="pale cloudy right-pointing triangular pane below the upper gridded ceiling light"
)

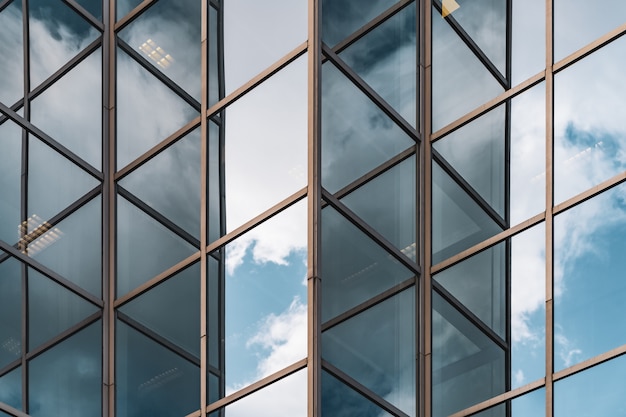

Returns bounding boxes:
[117,49,198,169]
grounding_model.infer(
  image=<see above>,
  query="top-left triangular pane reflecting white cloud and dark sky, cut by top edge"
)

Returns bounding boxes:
[28,0,100,88]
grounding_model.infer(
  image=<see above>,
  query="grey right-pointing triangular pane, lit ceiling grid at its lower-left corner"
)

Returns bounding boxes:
[27,136,100,233]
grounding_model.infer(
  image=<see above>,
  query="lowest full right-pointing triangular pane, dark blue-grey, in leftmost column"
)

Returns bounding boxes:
[28,268,98,348]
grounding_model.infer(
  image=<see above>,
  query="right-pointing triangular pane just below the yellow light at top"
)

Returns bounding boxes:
[432,1,504,131]
